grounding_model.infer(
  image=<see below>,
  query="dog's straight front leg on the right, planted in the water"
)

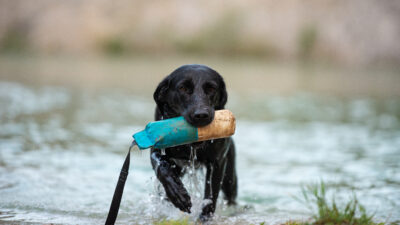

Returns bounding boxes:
[200,159,226,221]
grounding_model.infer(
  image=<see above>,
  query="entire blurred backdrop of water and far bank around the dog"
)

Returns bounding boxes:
[0,0,400,224]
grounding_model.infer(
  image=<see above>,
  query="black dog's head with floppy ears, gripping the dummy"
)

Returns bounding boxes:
[153,65,228,127]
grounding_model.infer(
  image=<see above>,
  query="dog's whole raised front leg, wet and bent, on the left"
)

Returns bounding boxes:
[150,149,192,213]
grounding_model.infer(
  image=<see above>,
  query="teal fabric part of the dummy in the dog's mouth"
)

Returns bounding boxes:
[133,116,198,149]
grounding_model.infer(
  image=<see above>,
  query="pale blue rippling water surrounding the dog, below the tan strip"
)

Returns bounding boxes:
[0,82,400,224]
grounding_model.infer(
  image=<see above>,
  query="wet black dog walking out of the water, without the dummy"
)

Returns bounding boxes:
[150,65,237,221]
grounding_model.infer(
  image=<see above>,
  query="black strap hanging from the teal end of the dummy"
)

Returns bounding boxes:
[106,141,136,225]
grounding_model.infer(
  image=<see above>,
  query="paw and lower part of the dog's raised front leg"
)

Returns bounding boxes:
[157,162,192,213]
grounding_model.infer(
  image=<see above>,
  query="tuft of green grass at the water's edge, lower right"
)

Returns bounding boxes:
[285,182,384,225]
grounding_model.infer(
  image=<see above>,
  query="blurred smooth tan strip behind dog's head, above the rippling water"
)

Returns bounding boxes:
[0,55,400,98]
